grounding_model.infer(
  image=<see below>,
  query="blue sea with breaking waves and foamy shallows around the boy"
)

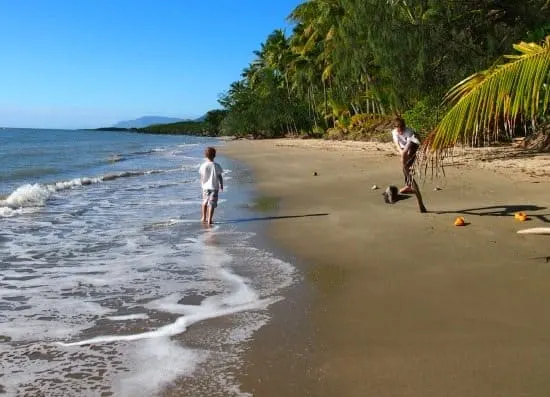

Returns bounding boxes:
[0,129,298,397]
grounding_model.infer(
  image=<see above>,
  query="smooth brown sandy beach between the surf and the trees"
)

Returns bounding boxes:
[224,139,550,397]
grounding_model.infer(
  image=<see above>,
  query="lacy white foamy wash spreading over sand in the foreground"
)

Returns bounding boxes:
[0,223,295,397]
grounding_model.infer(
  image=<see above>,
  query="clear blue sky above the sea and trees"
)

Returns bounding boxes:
[0,0,302,128]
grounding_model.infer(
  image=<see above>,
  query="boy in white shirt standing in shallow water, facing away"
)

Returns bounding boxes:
[199,147,223,225]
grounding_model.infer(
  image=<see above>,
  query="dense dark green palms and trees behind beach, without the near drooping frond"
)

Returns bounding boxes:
[218,0,550,139]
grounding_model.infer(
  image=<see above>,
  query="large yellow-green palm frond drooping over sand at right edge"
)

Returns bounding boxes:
[424,36,550,163]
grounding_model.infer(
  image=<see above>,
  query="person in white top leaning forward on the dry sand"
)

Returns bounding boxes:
[391,117,420,194]
